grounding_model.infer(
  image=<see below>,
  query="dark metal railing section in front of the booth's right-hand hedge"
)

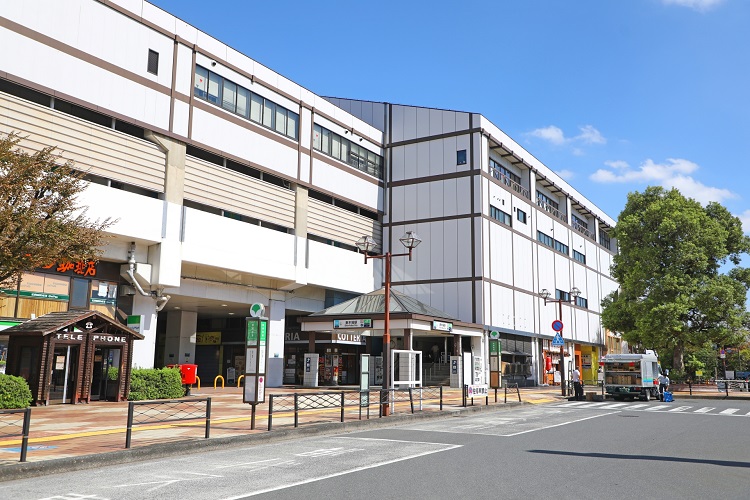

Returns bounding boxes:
[125,398,211,448]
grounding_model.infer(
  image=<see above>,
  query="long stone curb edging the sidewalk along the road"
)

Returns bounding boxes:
[0,401,530,482]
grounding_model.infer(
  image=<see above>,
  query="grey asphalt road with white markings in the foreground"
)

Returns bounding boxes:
[5,399,750,500]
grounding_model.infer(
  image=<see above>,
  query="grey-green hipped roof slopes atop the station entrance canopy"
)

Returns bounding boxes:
[310,288,458,321]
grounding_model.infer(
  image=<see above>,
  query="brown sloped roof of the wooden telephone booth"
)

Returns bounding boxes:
[3,309,144,340]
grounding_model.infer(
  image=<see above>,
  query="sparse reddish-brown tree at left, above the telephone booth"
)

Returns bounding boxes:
[0,133,112,286]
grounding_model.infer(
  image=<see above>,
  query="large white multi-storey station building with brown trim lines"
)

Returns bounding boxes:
[0,0,617,394]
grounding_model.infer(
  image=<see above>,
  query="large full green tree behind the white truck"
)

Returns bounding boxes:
[602,187,750,371]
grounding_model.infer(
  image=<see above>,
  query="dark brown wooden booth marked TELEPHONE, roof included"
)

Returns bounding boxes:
[3,310,143,405]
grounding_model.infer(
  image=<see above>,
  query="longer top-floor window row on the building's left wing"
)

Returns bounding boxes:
[193,66,299,140]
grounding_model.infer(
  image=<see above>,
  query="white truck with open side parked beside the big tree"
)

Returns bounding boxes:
[604,350,660,401]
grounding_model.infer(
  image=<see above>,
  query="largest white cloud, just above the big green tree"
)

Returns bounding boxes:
[590,158,737,204]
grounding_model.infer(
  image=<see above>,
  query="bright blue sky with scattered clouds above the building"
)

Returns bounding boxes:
[152,0,750,226]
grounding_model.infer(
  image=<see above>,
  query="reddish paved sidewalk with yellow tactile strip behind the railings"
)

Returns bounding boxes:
[0,386,750,481]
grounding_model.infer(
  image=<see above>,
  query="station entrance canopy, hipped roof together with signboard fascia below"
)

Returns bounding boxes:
[298,288,484,337]
